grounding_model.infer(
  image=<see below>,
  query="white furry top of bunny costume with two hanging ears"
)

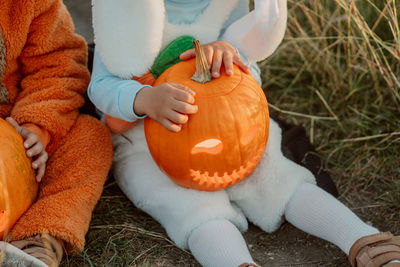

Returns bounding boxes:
[92,0,287,79]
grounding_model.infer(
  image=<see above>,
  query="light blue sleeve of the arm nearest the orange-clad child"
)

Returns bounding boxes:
[88,52,148,121]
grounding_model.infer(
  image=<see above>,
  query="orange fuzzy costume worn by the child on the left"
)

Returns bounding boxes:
[0,0,112,251]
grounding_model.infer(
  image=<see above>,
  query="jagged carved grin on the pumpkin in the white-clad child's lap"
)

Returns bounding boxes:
[190,146,265,191]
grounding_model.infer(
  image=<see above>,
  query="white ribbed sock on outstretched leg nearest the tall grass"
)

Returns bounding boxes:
[285,183,379,255]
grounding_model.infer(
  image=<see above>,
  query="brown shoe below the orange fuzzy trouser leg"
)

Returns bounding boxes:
[10,234,63,267]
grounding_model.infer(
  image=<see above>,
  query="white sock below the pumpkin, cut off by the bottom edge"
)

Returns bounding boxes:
[188,220,254,267]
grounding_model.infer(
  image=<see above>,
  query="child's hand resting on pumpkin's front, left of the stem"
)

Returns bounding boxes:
[133,83,197,132]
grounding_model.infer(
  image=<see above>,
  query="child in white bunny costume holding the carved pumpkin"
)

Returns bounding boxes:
[89,0,400,266]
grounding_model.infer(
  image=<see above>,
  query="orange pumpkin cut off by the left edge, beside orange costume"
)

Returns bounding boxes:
[0,119,38,239]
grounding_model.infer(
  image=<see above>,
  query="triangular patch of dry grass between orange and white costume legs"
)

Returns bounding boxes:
[63,183,196,266]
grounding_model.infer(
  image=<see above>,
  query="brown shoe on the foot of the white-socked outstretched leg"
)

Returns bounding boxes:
[349,232,400,267]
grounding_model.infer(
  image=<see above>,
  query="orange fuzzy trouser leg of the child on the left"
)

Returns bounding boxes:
[11,115,112,251]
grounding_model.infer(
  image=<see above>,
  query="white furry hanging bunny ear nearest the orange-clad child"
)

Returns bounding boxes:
[92,0,165,79]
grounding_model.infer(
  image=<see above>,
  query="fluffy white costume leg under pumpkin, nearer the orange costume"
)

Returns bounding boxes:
[113,122,247,249]
